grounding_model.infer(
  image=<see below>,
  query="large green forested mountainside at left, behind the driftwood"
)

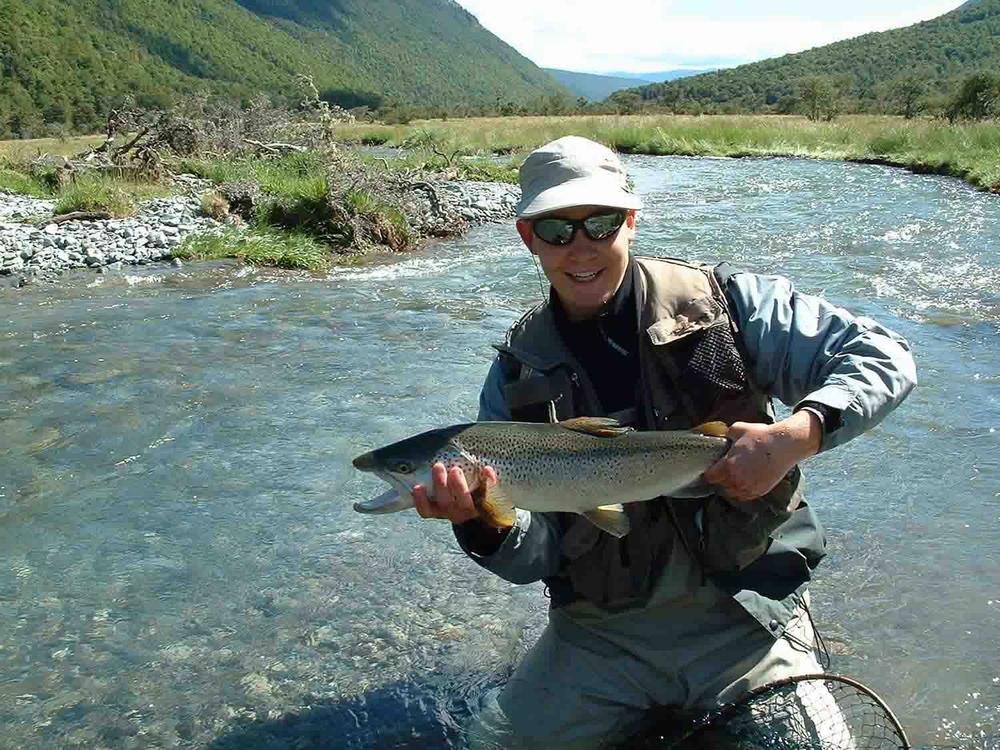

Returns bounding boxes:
[0,0,567,137]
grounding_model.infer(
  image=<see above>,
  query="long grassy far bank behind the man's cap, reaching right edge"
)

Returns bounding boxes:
[337,115,1000,193]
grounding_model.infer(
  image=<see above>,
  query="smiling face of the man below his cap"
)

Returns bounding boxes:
[517,206,635,320]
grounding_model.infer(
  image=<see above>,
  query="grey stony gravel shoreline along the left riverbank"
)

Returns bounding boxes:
[0,181,519,287]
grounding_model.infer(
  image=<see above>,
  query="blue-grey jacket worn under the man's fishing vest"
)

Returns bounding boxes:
[458,266,916,631]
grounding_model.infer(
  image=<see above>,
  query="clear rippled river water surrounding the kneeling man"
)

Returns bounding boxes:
[0,157,1000,748]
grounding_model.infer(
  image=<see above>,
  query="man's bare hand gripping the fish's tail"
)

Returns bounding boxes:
[705,410,823,500]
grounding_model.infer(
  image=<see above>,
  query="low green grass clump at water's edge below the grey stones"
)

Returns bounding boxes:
[173,228,332,271]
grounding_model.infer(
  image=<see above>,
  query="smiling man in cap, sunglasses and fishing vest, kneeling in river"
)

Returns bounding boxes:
[414,136,916,748]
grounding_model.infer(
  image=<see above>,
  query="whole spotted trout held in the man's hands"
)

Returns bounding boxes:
[354,417,729,537]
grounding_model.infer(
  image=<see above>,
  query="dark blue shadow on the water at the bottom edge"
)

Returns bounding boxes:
[204,673,506,750]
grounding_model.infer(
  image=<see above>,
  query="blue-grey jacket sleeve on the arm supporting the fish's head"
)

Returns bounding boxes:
[452,357,562,583]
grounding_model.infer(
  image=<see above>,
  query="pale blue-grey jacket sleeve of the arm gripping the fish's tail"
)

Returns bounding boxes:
[726,273,917,450]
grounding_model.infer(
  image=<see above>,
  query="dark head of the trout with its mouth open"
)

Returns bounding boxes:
[352,425,471,505]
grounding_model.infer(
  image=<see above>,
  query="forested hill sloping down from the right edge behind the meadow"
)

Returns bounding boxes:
[635,0,1000,112]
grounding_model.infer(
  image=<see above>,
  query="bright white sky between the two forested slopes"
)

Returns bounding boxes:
[457,0,961,73]
